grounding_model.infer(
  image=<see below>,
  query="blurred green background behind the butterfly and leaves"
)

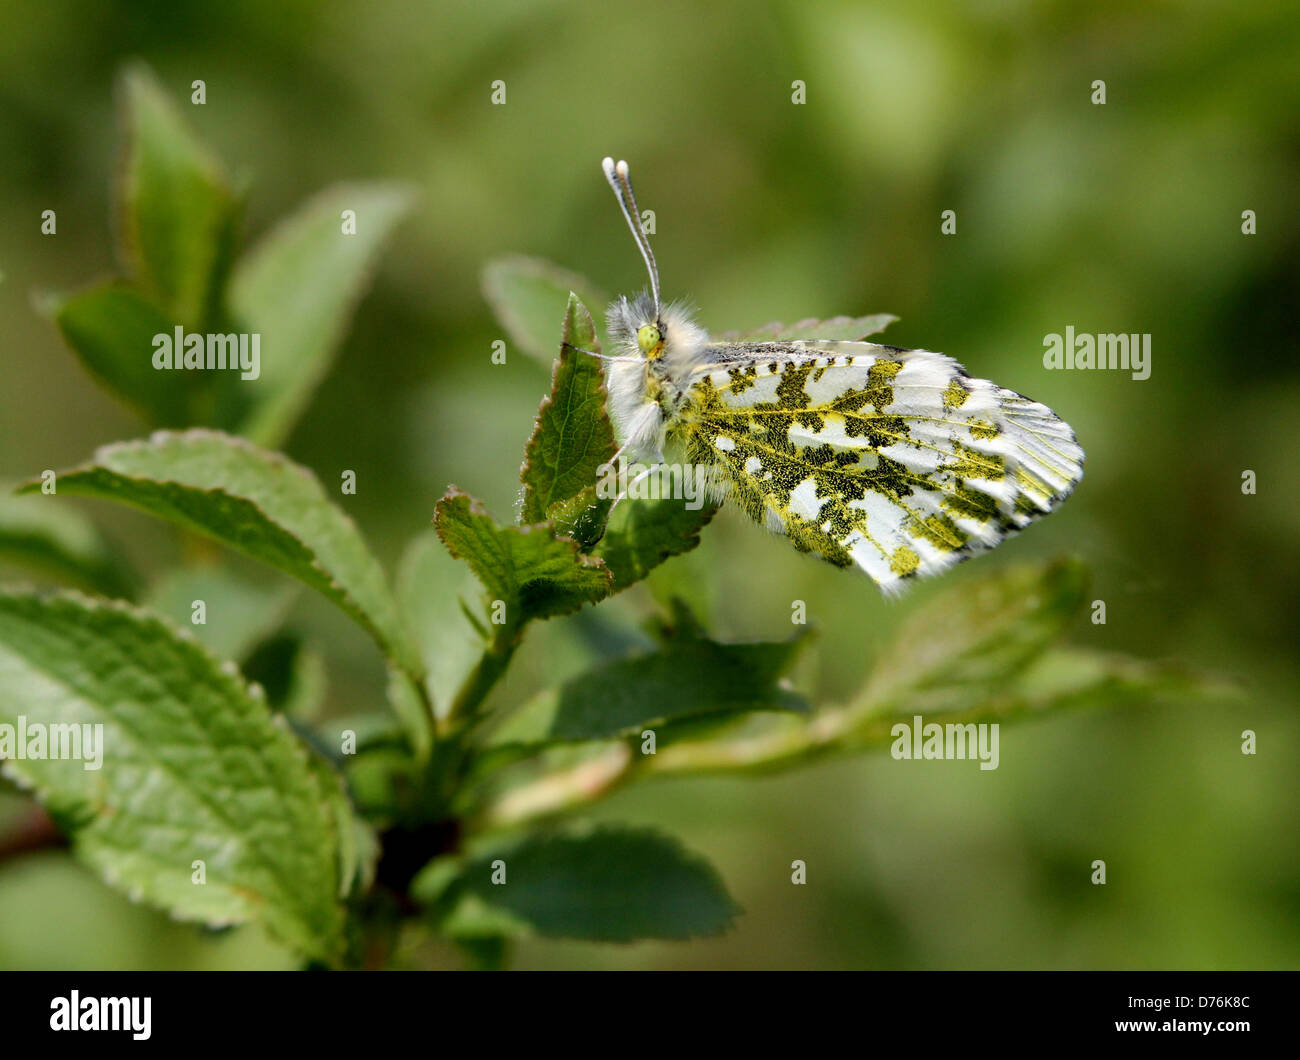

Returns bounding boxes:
[0,0,1300,968]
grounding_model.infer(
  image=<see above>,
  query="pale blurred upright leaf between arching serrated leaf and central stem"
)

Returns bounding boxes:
[398,532,486,718]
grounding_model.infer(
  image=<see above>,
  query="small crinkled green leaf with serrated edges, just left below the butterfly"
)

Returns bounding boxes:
[434,488,610,629]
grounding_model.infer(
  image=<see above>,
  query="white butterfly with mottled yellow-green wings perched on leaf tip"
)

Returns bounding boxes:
[602,159,1083,593]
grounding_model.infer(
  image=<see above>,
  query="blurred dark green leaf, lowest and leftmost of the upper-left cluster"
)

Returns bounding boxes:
[52,282,197,427]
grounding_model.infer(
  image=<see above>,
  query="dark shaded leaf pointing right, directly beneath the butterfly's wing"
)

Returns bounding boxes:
[493,636,807,744]
